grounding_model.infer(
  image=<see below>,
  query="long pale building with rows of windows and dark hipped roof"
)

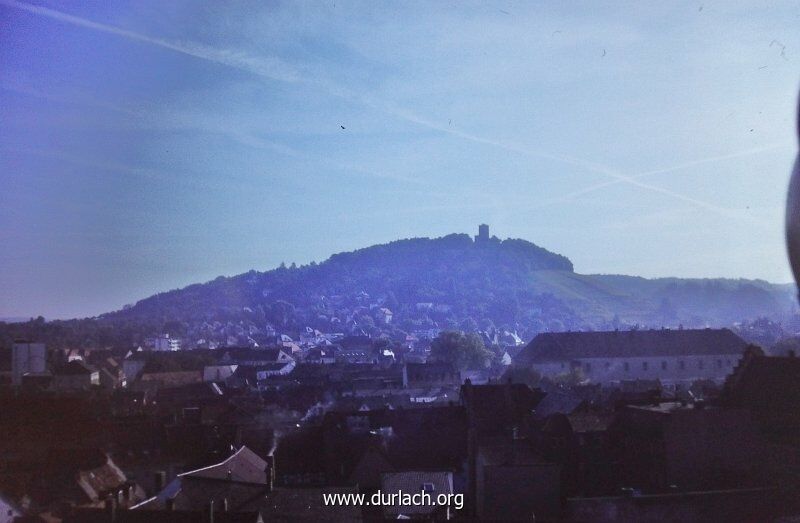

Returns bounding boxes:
[515,329,747,384]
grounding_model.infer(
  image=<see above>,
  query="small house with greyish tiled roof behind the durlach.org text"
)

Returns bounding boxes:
[381,471,456,519]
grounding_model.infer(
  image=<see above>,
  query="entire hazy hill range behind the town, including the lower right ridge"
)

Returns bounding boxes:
[0,234,795,346]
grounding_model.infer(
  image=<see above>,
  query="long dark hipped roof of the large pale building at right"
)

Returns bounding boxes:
[517,329,747,364]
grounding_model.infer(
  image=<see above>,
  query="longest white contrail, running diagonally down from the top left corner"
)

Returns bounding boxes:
[0,0,727,214]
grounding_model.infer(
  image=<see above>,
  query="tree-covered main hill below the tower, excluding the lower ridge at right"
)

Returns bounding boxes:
[103,234,573,323]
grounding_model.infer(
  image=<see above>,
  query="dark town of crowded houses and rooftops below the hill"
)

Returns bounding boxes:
[0,314,800,522]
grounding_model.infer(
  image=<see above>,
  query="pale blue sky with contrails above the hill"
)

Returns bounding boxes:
[0,0,800,319]
